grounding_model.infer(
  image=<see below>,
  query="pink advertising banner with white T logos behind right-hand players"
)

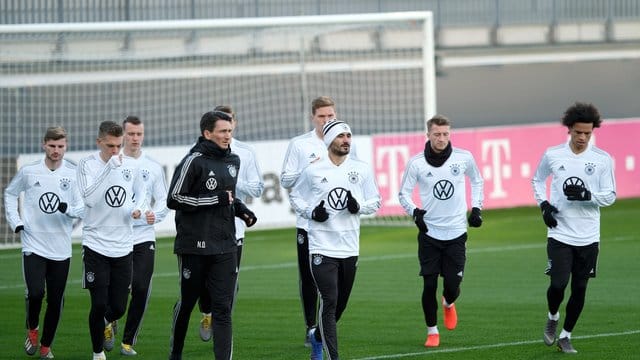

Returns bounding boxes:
[373,118,640,216]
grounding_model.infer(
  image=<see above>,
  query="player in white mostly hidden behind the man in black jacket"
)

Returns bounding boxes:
[198,105,264,341]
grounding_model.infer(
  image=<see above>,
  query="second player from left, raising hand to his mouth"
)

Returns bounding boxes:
[77,121,146,360]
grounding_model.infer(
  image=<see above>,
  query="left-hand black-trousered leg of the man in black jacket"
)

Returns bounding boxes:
[169,254,204,359]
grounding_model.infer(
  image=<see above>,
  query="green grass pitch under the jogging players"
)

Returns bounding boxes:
[0,199,640,360]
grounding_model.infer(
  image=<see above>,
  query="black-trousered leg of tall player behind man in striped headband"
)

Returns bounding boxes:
[296,228,318,338]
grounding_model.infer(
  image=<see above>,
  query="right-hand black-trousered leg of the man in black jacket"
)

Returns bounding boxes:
[206,253,238,359]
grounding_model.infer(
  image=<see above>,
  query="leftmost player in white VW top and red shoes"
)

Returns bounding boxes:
[4,126,84,359]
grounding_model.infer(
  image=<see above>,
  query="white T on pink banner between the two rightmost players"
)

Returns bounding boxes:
[482,139,511,199]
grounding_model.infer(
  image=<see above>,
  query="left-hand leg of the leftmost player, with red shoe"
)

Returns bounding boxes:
[22,253,47,355]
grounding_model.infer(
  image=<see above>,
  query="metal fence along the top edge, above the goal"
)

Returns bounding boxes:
[0,0,640,28]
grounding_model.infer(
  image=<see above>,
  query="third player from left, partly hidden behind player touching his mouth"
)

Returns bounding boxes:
[112,116,169,356]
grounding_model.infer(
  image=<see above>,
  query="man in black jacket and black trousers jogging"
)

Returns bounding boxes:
[167,111,256,360]
